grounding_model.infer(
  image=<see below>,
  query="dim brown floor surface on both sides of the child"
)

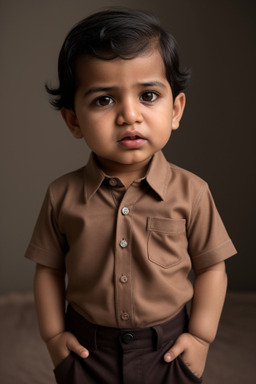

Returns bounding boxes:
[0,292,256,384]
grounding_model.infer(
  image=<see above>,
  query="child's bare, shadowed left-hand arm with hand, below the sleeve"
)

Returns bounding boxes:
[34,265,89,366]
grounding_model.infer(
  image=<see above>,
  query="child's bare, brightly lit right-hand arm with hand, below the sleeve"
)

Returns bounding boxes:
[164,261,227,377]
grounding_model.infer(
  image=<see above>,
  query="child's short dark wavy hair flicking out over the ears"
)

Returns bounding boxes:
[45,8,190,110]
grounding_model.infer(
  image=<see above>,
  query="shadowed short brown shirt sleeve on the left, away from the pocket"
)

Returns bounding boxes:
[25,188,68,269]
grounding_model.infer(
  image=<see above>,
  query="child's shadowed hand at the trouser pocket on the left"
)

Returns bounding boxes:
[46,332,89,367]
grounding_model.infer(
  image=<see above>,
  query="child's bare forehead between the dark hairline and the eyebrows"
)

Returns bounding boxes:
[76,49,168,87]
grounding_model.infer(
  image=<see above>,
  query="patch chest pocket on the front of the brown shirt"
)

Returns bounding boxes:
[147,217,187,268]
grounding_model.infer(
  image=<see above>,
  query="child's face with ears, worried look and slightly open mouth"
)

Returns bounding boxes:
[62,49,185,170]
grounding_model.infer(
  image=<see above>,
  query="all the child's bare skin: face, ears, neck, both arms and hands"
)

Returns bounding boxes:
[34,49,227,377]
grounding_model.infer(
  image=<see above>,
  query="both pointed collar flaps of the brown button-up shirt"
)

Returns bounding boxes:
[84,151,171,202]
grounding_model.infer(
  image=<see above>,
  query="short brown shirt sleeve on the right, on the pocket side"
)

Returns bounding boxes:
[188,184,236,270]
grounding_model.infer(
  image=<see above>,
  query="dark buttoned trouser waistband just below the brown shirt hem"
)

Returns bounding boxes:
[66,305,188,350]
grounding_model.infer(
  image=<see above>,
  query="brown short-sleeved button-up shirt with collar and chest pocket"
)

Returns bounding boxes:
[26,152,236,328]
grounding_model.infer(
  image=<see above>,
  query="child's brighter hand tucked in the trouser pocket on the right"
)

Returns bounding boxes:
[164,333,210,377]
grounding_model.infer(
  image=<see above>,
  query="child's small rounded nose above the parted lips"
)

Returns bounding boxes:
[117,98,143,125]
